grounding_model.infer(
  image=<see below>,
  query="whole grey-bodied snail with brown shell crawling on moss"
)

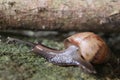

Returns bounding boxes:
[8,32,110,74]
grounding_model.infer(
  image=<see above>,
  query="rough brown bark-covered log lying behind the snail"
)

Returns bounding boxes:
[0,0,120,32]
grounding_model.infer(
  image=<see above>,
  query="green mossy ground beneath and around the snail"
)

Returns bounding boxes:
[0,34,120,80]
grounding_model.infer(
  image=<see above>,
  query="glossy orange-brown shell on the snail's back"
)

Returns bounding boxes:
[64,32,110,64]
